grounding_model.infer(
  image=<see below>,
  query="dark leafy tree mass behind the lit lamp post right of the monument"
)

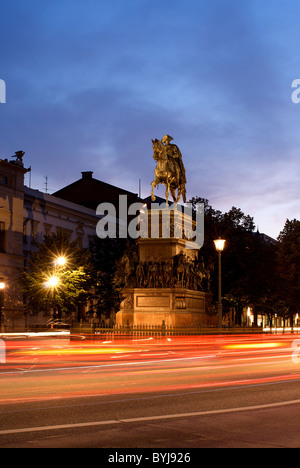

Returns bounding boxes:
[190,197,276,324]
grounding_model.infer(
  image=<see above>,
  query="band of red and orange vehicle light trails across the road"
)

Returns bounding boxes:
[0,335,300,404]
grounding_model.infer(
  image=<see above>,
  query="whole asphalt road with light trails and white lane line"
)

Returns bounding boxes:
[0,335,300,450]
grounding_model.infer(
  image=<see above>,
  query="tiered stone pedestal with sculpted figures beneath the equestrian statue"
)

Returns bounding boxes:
[116,210,211,328]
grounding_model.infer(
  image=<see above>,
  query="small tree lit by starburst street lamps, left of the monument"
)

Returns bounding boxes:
[21,232,95,318]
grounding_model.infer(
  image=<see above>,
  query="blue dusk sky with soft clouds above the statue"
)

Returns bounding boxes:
[0,0,300,238]
